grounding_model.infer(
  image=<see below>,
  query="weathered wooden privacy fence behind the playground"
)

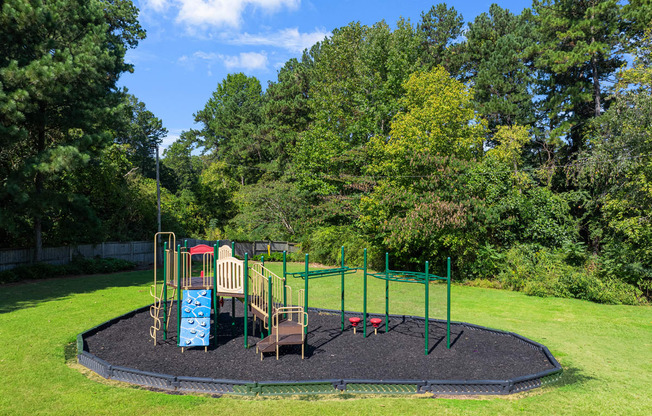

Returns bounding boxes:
[0,238,298,271]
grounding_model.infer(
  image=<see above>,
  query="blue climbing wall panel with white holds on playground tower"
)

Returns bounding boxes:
[179,289,211,347]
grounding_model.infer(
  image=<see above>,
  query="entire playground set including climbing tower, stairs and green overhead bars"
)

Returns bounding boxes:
[150,233,451,360]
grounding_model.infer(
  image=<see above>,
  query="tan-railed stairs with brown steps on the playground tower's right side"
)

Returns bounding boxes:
[250,263,308,360]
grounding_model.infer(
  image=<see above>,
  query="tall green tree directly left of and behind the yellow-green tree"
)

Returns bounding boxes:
[293,20,420,196]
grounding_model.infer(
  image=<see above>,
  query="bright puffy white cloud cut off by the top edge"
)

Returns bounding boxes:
[155,0,301,31]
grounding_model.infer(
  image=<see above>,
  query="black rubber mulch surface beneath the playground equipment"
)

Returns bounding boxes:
[86,299,553,381]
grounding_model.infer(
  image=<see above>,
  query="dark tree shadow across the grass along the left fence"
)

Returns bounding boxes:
[0,270,153,314]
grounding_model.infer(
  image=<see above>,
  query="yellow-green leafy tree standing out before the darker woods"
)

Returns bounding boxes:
[360,67,486,263]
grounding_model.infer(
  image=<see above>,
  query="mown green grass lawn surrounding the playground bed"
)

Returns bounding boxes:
[0,264,652,416]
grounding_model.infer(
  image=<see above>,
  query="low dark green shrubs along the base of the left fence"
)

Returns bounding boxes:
[0,257,136,284]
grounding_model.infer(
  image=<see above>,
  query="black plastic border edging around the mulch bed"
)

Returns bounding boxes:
[77,305,563,396]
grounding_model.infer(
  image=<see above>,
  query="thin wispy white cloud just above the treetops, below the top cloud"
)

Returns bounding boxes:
[228,27,331,52]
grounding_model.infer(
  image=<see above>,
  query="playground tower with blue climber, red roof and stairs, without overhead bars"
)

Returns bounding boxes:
[150,232,308,359]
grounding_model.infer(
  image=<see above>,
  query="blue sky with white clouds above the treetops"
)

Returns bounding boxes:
[120,0,531,151]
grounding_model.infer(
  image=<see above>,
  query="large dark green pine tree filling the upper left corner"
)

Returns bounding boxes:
[0,0,145,260]
